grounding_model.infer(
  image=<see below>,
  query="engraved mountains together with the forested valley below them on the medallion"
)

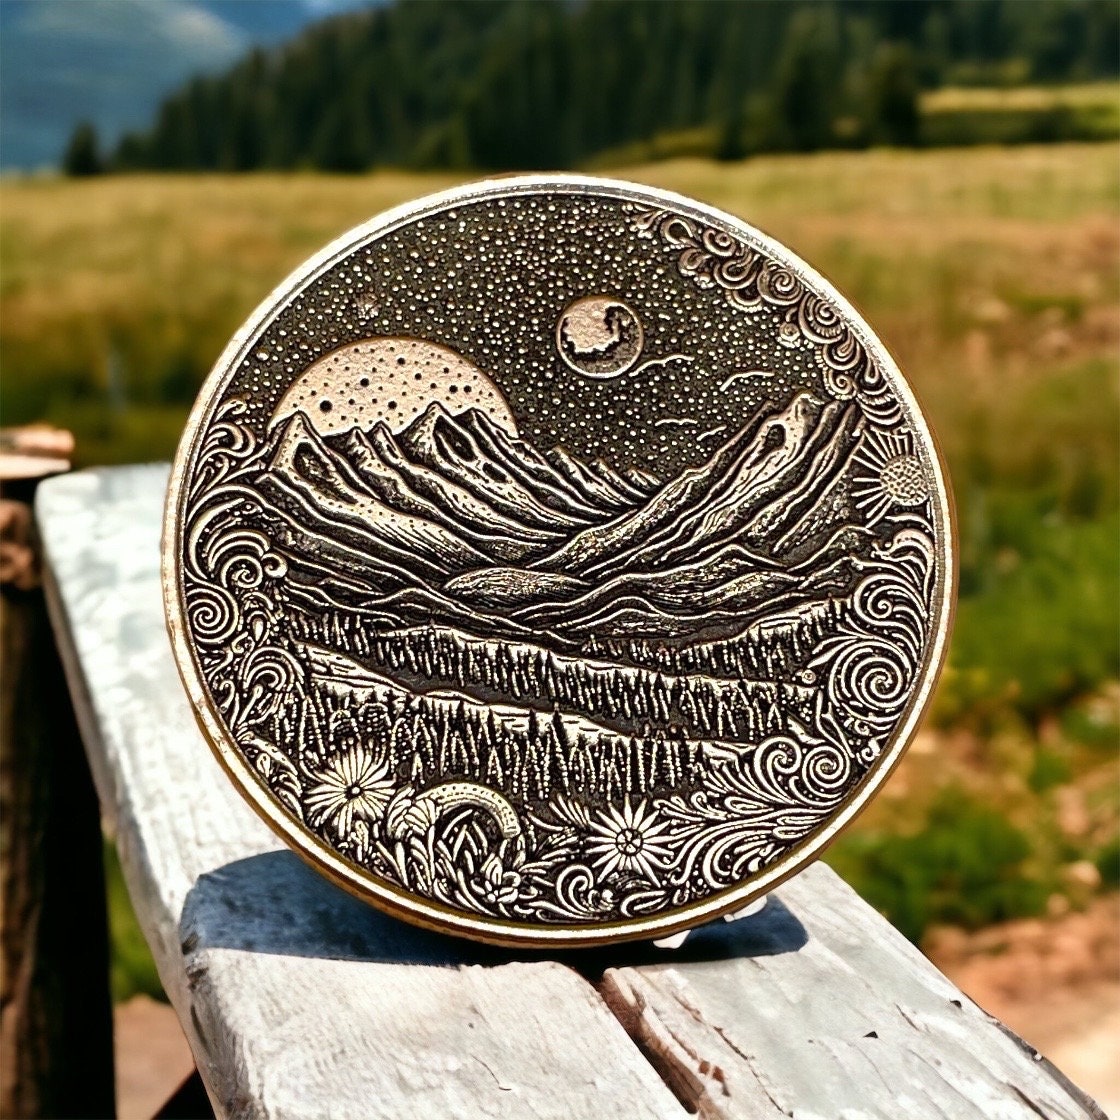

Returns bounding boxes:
[234,393,874,801]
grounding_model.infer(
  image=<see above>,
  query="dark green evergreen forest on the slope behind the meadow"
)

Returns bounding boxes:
[72,0,1120,174]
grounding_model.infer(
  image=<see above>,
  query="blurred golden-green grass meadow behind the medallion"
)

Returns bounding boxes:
[0,144,1120,994]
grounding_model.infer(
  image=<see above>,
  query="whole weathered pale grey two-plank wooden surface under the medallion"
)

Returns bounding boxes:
[39,467,1101,1120]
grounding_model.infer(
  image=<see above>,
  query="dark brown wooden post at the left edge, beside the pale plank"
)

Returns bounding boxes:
[0,429,115,1120]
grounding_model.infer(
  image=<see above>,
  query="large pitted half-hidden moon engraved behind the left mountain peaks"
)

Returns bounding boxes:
[273,338,517,436]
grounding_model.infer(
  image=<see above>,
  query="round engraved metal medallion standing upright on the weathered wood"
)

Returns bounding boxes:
[164,176,954,944]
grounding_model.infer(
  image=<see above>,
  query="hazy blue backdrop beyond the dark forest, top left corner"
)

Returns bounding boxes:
[0,0,373,170]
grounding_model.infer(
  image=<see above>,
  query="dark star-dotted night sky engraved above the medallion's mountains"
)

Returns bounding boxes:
[221,187,900,479]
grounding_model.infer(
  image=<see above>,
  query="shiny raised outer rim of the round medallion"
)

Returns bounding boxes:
[160,175,959,948]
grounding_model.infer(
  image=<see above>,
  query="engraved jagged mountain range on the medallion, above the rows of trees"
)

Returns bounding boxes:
[256,393,867,646]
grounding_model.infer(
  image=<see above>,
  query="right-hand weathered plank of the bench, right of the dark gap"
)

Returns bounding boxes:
[601,864,1105,1120]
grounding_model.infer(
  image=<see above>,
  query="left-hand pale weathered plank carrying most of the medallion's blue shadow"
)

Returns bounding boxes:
[37,466,685,1120]
